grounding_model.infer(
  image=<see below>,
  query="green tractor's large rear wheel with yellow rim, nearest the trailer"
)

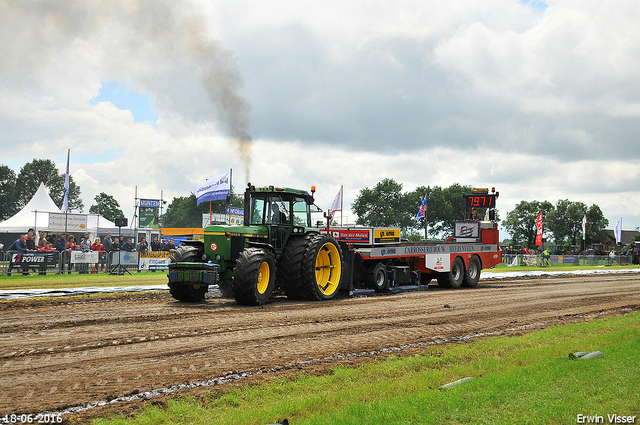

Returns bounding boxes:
[302,235,342,301]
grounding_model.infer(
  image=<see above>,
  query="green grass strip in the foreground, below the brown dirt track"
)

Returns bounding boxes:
[89,312,640,425]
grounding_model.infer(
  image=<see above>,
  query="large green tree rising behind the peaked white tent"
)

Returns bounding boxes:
[16,159,84,212]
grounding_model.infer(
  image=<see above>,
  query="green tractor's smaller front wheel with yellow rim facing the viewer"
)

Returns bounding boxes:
[231,248,276,305]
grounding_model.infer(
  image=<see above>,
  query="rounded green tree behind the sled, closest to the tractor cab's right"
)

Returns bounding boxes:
[351,178,420,229]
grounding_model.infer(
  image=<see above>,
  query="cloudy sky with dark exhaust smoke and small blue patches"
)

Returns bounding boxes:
[0,0,640,235]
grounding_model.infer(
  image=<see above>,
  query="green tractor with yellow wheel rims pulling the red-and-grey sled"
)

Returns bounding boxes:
[168,183,343,305]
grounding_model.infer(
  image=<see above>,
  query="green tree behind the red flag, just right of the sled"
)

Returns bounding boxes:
[503,201,554,248]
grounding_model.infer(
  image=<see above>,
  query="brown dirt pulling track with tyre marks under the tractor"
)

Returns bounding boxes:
[0,274,640,415]
